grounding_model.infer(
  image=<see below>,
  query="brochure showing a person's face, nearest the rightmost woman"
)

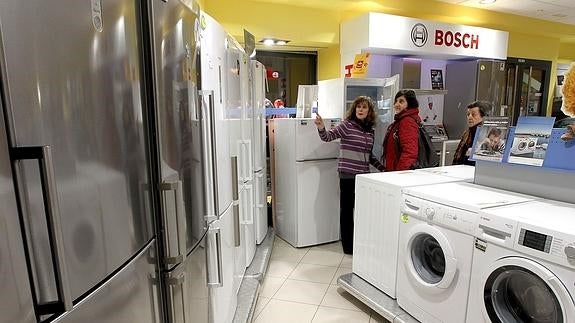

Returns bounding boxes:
[471,117,509,163]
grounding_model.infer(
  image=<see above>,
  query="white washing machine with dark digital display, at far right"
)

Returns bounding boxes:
[467,201,575,323]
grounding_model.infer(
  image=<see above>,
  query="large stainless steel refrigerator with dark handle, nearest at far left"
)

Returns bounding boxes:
[0,0,160,323]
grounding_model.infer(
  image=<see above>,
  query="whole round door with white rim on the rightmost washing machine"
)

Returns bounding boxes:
[482,257,575,323]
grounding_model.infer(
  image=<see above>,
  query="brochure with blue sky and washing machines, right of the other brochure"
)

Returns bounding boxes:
[507,117,555,166]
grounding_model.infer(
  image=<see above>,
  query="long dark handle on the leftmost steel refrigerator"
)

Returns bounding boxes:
[10,146,74,314]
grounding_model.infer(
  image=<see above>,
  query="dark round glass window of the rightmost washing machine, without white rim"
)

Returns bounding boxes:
[484,265,565,323]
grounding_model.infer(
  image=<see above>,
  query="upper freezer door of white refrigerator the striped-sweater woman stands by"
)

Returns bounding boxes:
[294,119,339,161]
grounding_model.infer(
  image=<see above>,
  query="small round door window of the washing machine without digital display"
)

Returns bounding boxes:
[411,233,445,284]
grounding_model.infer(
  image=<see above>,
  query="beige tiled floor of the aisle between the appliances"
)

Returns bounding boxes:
[253,236,387,323]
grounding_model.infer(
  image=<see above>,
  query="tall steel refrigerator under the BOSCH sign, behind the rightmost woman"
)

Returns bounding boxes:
[444,60,507,139]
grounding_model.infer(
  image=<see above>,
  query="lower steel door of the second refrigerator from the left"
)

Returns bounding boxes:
[164,235,209,323]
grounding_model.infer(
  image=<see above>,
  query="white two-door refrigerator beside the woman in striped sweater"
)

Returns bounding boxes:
[274,118,340,247]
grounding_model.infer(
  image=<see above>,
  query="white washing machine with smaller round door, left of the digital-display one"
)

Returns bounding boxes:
[397,182,533,323]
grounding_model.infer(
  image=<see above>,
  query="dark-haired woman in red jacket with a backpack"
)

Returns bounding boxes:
[382,90,421,172]
